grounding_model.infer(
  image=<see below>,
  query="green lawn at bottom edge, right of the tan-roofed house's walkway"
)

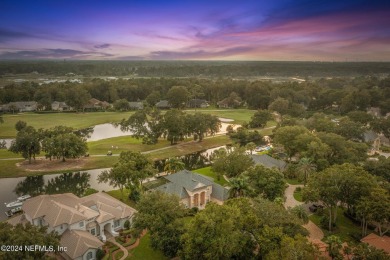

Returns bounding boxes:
[128,233,168,260]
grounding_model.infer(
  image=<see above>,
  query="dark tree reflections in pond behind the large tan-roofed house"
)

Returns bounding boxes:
[14,172,91,197]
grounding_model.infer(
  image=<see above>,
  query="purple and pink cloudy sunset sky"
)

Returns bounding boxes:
[0,0,390,61]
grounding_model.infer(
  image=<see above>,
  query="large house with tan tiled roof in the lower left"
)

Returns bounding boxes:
[8,192,136,260]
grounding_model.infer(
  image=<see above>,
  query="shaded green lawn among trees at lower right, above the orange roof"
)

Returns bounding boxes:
[309,208,361,243]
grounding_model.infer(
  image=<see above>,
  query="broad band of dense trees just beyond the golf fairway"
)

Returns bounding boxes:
[0,76,390,115]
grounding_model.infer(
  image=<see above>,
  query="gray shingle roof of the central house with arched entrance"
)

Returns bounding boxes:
[155,170,229,201]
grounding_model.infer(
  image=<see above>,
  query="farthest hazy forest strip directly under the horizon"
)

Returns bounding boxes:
[0,60,390,77]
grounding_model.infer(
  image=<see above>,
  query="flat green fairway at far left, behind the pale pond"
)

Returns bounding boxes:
[0,112,134,138]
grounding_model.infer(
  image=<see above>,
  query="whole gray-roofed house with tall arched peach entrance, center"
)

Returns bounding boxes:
[154,170,229,209]
